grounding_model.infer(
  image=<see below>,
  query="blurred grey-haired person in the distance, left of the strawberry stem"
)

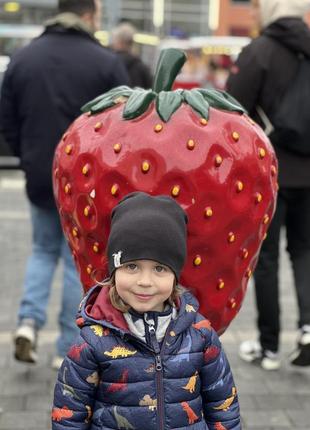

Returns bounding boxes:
[111,22,153,89]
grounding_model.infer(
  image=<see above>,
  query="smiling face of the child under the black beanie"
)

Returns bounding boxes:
[115,260,175,313]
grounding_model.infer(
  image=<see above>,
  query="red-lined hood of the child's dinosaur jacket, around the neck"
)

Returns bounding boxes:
[76,285,199,334]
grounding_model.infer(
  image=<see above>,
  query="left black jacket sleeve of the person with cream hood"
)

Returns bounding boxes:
[226,44,264,116]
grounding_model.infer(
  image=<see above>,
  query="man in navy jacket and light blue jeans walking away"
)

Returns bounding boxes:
[0,0,128,367]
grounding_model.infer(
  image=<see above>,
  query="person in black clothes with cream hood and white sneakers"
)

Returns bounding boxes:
[227,0,310,370]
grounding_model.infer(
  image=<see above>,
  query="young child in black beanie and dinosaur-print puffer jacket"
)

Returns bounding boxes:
[52,192,241,430]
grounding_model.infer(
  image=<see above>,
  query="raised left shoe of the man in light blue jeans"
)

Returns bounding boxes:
[14,319,38,364]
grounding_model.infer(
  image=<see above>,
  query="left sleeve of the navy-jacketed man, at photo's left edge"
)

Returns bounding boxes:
[0,65,21,157]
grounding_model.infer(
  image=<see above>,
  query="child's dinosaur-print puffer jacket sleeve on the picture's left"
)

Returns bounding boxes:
[52,336,99,430]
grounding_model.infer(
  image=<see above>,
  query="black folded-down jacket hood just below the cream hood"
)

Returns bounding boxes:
[262,18,310,57]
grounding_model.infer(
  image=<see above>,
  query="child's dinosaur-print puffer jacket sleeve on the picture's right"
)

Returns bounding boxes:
[200,329,241,430]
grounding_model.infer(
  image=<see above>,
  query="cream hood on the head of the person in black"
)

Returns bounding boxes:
[259,0,310,28]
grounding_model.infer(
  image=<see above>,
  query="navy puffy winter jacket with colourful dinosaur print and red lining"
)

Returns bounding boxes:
[52,287,241,430]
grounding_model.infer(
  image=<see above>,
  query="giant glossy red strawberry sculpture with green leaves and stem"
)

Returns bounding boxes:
[53,49,277,333]
